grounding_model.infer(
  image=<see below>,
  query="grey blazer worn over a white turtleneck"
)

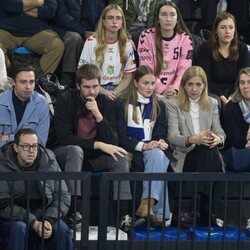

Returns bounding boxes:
[166,97,226,173]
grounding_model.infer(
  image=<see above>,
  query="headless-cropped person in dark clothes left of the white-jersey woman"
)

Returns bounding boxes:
[52,0,108,87]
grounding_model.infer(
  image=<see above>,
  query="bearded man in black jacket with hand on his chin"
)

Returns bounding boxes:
[54,64,131,200]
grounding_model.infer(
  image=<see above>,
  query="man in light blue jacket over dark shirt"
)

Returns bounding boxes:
[0,64,50,147]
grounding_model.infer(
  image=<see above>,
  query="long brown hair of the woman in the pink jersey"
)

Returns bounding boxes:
[155,1,192,76]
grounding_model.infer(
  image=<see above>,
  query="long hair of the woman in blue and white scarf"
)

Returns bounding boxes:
[121,65,160,123]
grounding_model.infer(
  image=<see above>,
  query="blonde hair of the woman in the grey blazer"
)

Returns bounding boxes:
[177,66,212,112]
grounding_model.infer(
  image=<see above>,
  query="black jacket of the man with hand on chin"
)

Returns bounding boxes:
[54,90,118,159]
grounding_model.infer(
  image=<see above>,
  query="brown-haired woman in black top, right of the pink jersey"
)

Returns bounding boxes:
[197,12,250,104]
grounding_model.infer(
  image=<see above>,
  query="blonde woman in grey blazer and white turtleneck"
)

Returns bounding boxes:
[167,66,225,228]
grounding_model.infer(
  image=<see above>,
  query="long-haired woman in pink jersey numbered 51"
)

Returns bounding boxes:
[137,1,193,97]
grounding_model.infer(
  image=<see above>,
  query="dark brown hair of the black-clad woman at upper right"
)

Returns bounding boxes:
[210,12,239,61]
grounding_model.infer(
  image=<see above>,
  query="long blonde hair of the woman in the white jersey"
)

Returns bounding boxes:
[95,4,128,69]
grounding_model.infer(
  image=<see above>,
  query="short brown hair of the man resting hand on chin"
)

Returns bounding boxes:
[76,64,101,86]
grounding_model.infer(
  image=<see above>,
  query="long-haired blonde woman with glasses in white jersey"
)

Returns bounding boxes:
[78,4,136,100]
